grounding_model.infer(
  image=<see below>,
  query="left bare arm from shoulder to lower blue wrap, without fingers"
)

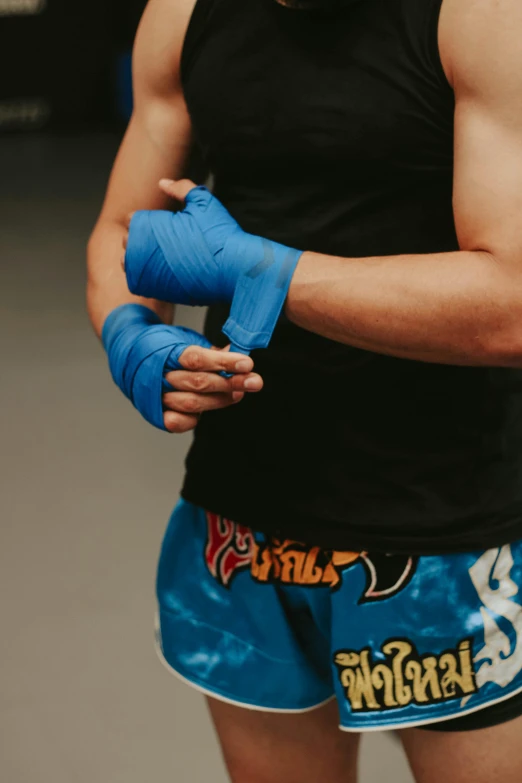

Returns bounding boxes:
[87,0,195,335]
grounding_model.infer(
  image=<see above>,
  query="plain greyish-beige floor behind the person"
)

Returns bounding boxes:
[0,136,411,783]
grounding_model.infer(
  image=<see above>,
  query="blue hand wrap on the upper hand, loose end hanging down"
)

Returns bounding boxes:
[125,186,302,353]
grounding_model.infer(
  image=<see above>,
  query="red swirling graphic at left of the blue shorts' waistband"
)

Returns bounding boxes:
[205,512,254,587]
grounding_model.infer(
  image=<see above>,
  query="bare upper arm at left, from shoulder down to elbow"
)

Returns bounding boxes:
[96,0,194,222]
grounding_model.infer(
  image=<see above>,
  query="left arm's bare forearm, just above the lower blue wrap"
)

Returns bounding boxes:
[87,218,174,337]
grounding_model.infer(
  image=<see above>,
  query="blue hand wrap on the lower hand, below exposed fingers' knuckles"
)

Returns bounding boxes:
[102,304,211,430]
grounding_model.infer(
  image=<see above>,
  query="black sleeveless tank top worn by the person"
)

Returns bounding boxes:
[178,0,522,553]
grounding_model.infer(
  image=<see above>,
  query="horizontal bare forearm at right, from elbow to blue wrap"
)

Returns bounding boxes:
[286,251,522,366]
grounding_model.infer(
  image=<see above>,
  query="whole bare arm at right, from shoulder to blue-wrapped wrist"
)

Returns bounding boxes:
[287,0,522,366]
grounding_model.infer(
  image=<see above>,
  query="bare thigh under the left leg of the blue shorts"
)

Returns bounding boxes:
[208,699,359,783]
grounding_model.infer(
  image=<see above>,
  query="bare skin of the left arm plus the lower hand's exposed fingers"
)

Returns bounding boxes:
[87,0,263,432]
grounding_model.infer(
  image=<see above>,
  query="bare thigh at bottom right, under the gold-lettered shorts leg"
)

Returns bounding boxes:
[401,718,522,783]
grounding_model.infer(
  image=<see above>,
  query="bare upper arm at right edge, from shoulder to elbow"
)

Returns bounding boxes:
[445,0,522,268]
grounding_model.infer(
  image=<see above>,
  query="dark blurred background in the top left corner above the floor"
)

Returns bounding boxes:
[0,0,146,132]
